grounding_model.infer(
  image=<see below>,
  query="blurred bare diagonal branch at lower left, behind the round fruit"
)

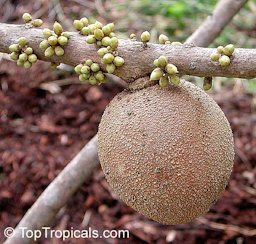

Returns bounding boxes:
[5,135,99,244]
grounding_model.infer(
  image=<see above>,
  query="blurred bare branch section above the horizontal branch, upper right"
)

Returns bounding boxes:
[186,0,247,47]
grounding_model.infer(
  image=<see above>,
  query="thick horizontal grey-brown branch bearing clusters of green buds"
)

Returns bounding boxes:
[0,24,256,82]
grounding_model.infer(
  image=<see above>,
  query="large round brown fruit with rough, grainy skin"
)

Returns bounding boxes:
[98,80,234,224]
